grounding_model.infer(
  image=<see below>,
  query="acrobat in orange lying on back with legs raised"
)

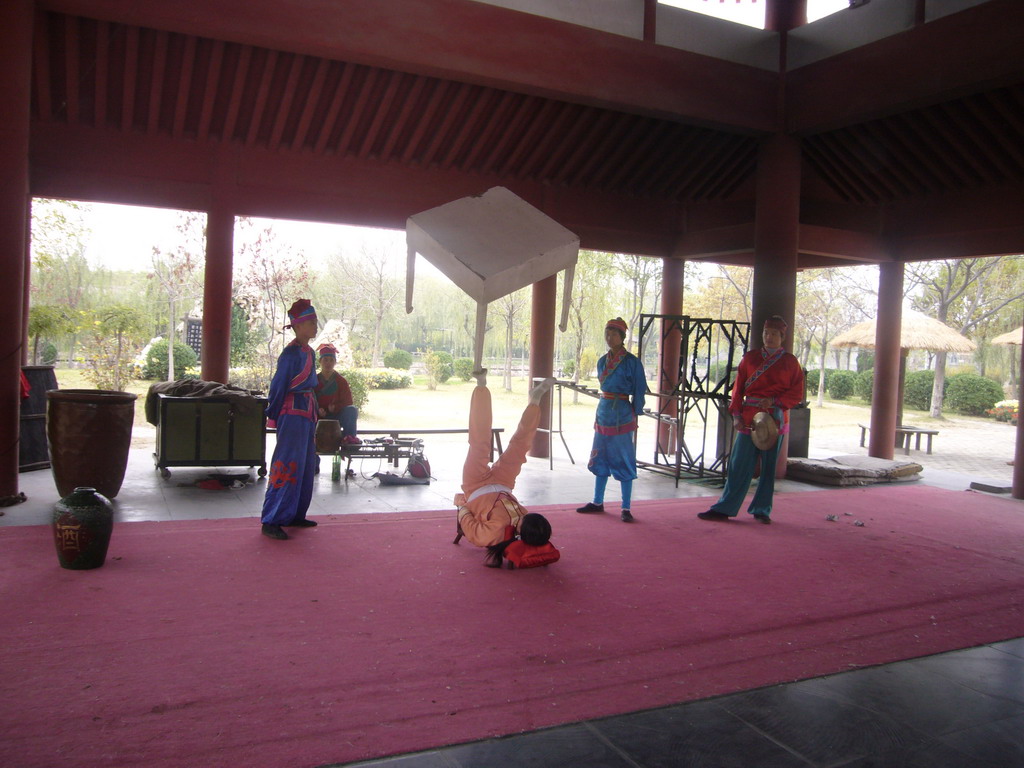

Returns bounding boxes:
[455,371,558,567]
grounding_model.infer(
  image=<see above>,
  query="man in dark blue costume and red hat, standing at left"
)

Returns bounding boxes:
[260,299,317,539]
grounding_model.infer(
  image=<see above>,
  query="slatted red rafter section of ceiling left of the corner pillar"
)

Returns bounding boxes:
[33,13,757,201]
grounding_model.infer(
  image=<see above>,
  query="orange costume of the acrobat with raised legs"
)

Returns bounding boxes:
[455,386,541,547]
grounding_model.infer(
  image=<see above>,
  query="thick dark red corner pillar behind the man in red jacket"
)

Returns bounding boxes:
[750,133,800,477]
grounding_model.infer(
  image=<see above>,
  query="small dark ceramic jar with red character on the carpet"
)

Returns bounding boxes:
[51,486,114,570]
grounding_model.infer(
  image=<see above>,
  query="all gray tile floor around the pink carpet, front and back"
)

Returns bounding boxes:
[9,428,1024,768]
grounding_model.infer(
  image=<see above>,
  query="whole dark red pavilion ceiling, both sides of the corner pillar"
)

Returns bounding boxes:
[22,0,1024,265]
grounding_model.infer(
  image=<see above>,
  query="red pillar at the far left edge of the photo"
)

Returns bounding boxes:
[0,0,33,498]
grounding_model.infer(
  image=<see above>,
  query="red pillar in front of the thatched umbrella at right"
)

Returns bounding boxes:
[867,261,903,460]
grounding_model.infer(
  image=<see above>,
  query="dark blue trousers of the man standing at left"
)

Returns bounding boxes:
[260,415,319,525]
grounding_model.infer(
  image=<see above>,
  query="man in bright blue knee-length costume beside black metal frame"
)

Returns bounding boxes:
[577,317,647,522]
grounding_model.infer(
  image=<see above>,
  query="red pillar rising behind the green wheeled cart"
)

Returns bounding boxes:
[203,203,234,384]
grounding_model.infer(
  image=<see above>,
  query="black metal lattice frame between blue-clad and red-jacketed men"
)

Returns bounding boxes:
[637,314,751,485]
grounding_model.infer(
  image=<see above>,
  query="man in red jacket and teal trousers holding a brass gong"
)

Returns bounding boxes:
[697,314,804,523]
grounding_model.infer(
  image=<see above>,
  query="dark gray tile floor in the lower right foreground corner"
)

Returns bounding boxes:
[335,639,1024,768]
